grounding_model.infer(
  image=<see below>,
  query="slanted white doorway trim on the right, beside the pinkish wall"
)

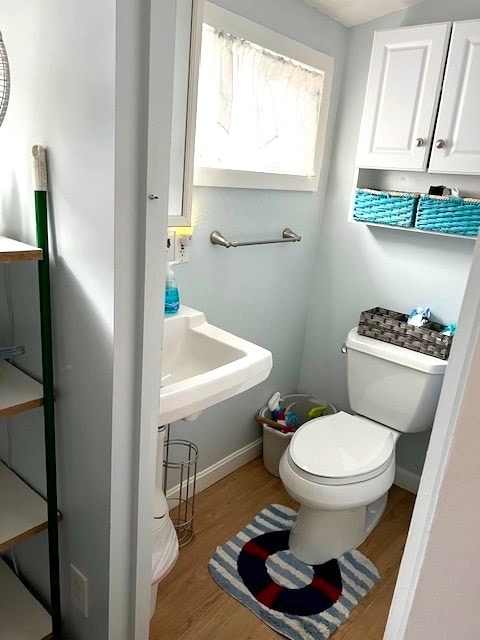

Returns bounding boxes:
[384,236,480,640]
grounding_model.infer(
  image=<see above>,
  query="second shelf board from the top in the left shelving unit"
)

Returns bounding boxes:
[0,360,43,418]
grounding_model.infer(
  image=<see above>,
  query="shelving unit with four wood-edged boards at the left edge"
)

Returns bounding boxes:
[0,224,62,640]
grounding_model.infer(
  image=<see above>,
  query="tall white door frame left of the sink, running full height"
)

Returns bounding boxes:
[108,0,176,640]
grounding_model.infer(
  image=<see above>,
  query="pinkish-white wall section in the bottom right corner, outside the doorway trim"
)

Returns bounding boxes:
[404,304,480,640]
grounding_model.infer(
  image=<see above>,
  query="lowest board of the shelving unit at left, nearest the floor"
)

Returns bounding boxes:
[0,560,52,640]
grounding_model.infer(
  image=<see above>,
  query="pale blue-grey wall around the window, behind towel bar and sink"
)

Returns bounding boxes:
[173,0,347,469]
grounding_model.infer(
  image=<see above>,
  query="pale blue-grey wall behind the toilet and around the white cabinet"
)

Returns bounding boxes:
[300,0,480,473]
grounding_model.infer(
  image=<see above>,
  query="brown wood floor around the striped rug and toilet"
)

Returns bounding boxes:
[150,458,415,640]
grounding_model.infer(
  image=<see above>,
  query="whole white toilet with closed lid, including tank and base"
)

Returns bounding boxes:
[280,328,447,564]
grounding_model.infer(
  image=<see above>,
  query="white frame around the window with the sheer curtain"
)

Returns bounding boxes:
[193,2,334,191]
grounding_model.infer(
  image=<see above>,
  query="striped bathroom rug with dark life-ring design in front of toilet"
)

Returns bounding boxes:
[208,504,379,640]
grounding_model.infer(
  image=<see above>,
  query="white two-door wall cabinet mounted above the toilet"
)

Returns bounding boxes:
[356,20,480,175]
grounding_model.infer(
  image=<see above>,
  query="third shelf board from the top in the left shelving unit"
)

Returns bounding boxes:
[0,462,47,552]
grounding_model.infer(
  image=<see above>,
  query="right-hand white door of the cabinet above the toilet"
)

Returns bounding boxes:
[429,20,480,174]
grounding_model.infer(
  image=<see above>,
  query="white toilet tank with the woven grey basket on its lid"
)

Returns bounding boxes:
[346,327,448,433]
